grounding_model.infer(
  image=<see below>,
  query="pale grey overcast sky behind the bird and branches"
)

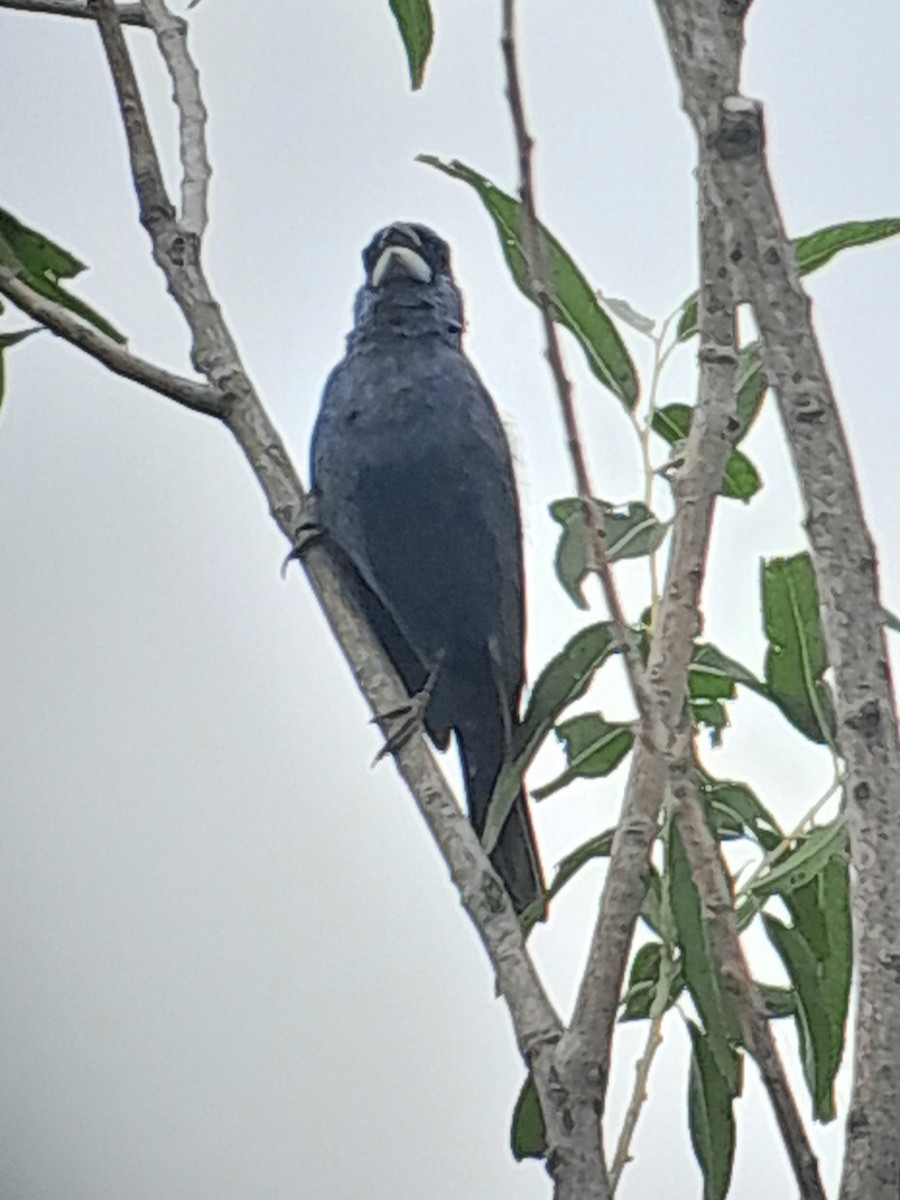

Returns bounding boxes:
[0,0,900,1200]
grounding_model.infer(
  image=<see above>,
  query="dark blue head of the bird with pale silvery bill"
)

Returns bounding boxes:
[354,222,463,341]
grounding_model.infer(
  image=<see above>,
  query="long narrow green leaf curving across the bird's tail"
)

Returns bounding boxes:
[481,620,617,854]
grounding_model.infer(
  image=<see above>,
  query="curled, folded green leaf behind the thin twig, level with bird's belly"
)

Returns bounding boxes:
[550,498,667,608]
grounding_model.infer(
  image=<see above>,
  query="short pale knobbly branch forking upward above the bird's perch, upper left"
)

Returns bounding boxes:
[144,0,212,238]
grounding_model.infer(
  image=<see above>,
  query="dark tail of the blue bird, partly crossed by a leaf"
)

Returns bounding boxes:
[457,722,544,913]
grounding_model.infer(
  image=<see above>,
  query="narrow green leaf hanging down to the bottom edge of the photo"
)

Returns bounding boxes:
[688,1021,740,1200]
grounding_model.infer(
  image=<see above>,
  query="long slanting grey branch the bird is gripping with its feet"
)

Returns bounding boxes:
[74,0,562,1104]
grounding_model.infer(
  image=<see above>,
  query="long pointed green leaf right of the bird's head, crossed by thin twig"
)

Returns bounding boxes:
[419,155,640,410]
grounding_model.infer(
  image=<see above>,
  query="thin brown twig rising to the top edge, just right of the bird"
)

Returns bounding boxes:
[500,0,646,714]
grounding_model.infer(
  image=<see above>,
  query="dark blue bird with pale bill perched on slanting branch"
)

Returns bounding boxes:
[311,224,541,912]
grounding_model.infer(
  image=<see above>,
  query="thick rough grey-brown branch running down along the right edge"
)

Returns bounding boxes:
[656,0,900,1200]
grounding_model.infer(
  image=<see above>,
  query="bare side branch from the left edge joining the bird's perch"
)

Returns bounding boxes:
[0,264,224,416]
